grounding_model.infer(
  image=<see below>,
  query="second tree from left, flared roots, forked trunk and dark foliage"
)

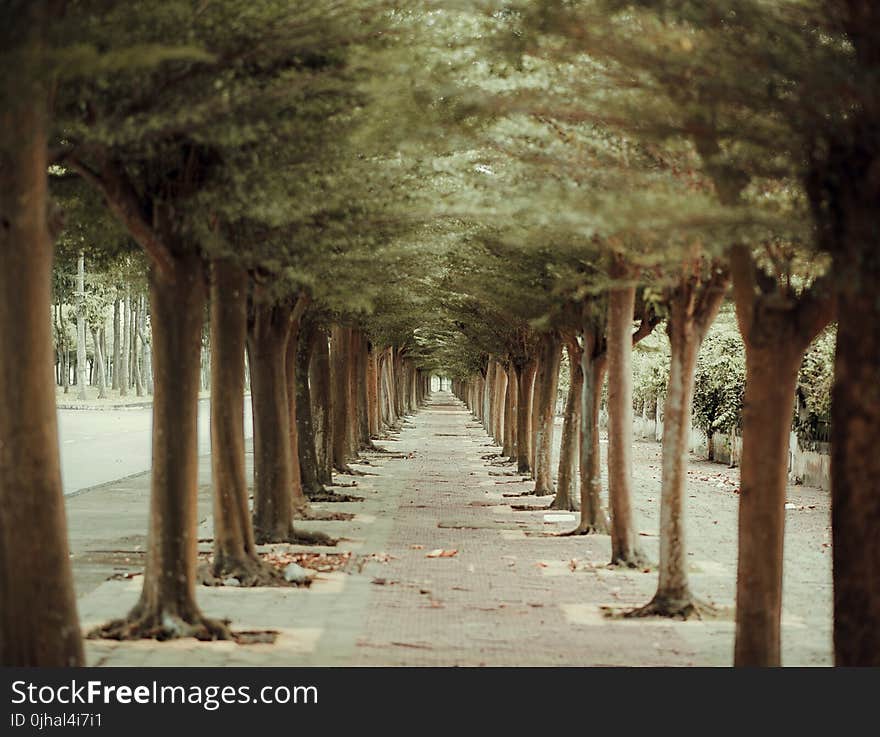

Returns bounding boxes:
[59,2,378,638]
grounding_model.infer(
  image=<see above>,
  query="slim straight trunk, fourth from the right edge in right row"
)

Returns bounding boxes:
[608,276,646,568]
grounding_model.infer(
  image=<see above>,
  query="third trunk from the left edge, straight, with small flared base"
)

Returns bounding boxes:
[211,261,277,586]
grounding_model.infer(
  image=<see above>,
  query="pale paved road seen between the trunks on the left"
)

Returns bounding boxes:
[58,397,253,494]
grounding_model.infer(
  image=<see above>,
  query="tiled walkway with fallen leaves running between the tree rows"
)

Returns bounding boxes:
[68,393,831,665]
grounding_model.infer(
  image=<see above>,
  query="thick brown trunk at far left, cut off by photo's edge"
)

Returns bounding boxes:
[0,12,83,667]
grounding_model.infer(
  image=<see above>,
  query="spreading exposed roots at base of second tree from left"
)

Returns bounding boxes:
[86,606,232,642]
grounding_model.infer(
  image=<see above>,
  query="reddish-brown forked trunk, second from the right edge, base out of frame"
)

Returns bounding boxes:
[728,246,833,666]
